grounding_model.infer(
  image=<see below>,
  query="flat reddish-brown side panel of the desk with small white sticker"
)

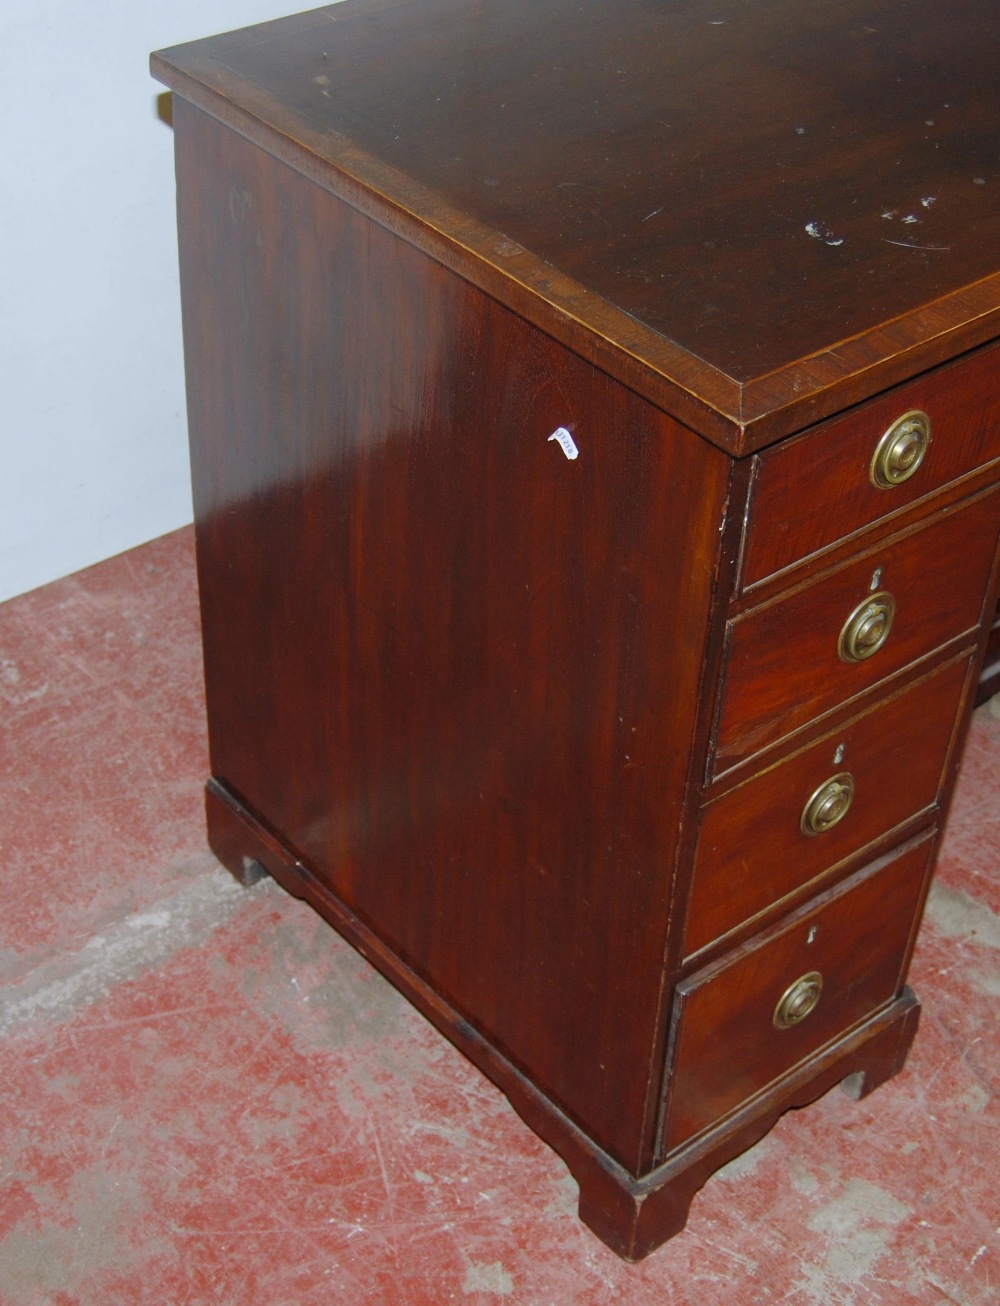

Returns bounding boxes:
[175,101,731,1173]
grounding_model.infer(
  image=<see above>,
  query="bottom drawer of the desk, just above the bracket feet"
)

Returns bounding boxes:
[663,836,933,1152]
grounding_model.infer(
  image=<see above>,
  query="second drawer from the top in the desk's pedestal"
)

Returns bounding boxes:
[715,487,1000,773]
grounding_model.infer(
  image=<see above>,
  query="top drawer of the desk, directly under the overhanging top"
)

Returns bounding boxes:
[743,347,1000,588]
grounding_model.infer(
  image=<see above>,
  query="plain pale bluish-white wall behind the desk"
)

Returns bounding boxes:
[0,0,309,599]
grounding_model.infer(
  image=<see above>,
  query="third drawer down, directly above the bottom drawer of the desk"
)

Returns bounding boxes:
[684,657,971,956]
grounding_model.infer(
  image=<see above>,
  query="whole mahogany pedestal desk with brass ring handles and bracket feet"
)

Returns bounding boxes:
[153,0,1000,1259]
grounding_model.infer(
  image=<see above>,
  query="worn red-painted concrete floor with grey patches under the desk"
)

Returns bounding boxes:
[0,530,1000,1306]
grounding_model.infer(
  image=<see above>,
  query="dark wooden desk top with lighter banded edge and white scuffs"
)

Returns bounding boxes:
[154,0,1000,452]
